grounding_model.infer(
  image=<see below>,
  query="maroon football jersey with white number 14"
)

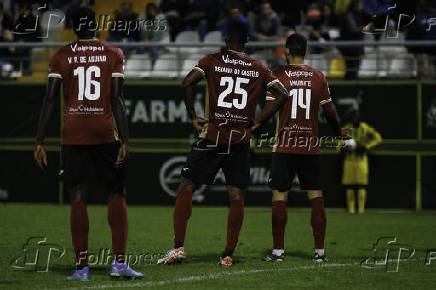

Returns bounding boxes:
[266,65,331,154]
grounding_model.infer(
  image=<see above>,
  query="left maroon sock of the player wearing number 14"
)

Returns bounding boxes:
[271,201,288,250]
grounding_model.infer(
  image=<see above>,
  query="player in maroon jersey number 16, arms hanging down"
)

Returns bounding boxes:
[34,8,142,281]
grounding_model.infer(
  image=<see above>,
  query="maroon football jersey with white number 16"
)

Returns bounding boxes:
[48,40,124,145]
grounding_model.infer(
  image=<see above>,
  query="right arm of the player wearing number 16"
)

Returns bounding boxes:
[111,77,129,164]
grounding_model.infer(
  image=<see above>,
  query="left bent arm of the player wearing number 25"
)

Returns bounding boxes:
[182,69,207,133]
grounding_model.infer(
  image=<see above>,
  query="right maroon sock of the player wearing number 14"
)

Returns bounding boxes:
[309,197,327,249]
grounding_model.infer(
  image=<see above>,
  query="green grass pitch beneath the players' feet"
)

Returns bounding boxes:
[0,204,436,289]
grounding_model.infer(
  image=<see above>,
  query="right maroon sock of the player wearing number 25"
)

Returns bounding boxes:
[226,199,244,256]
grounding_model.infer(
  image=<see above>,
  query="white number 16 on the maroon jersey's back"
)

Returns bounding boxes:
[74,65,100,101]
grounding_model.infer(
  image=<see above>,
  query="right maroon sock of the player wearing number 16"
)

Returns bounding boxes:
[107,197,129,263]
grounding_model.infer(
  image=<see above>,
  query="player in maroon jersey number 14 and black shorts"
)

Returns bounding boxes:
[260,34,350,262]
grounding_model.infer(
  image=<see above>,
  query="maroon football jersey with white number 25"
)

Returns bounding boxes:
[194,50,278,144]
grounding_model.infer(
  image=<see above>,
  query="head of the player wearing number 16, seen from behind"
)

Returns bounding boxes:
[71,7,97,39]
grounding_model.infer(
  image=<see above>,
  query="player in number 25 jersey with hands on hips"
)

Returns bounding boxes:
[158,22,287,266]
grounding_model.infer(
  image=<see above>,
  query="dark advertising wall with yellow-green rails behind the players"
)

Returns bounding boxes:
[0,81,436,210]
